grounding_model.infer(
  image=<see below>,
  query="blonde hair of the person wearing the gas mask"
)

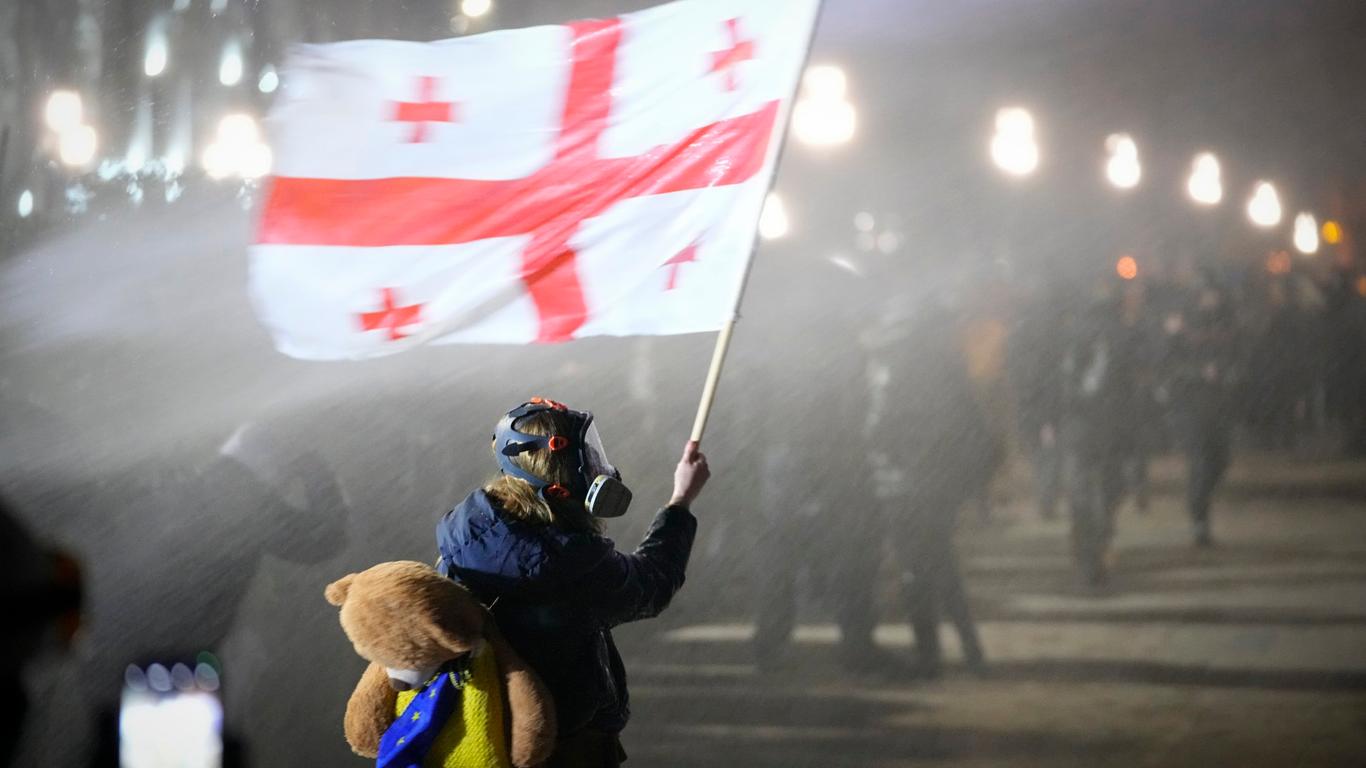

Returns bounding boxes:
[484,410,602,533]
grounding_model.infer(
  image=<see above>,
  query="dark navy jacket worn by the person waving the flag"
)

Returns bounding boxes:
[436,491,697,738]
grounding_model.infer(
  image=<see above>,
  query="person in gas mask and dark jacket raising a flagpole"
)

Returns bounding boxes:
[437,398,710,765]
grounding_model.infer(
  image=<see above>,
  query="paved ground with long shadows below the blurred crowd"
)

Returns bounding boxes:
[623,458,1366,767]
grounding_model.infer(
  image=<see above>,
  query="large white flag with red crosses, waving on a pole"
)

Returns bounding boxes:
[251,0,818,359]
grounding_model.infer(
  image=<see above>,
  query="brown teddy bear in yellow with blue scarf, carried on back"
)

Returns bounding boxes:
[325,560,555,768]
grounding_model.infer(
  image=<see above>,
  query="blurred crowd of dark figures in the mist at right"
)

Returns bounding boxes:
[739,248,1366,676]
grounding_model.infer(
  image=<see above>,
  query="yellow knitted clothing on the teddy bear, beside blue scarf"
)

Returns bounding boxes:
[398,648,512,768]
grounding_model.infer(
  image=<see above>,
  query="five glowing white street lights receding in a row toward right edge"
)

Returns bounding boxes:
[989,107,1340,256]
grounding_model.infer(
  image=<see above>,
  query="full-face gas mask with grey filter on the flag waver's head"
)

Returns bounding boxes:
[493,398,631,518]
